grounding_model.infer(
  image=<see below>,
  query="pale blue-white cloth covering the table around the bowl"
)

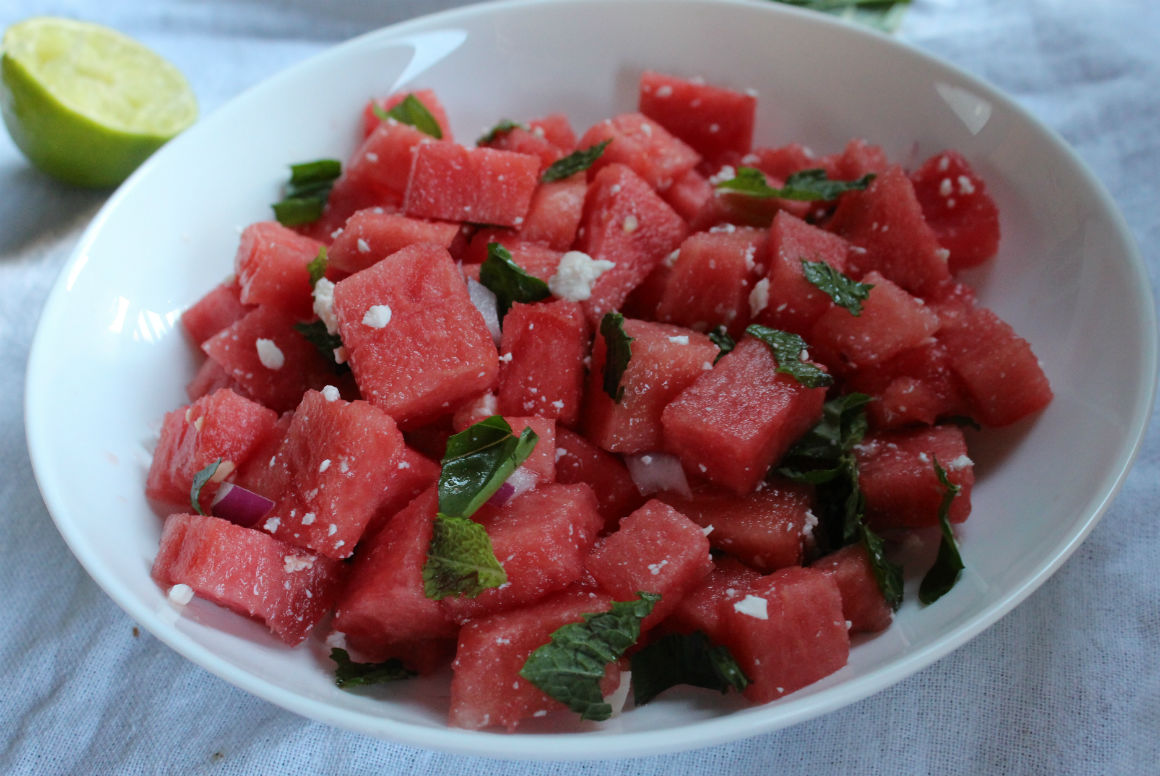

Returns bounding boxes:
[0,0,1160,776]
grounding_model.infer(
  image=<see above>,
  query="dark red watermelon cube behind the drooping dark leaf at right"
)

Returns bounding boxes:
[854,426,974,529]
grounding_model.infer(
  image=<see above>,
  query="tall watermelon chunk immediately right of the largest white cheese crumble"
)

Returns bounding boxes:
[577,165,688,324]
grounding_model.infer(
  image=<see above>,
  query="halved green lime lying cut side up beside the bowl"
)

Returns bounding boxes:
[0,16,197,187]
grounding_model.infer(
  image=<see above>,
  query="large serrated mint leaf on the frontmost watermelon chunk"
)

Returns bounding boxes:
[520,593,660,720]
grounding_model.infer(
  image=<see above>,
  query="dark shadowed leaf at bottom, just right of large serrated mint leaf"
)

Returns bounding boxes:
[632,631,749,706]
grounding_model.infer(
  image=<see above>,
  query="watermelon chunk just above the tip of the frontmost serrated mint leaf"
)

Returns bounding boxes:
[587,499,713,632]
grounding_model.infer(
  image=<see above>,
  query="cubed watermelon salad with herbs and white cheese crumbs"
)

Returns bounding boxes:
[145,72,1052,731]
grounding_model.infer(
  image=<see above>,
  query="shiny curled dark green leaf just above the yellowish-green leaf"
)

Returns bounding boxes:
[438,415,537,517]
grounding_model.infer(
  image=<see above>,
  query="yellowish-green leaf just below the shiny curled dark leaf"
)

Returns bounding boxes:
[423,514,507,600]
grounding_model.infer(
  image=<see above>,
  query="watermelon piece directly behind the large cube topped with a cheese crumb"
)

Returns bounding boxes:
[327,208,459,274]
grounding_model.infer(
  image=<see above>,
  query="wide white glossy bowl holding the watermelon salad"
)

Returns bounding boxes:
[27,0,1157,759]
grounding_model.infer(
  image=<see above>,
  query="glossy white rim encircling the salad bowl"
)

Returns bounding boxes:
[24,0,1158,760]
